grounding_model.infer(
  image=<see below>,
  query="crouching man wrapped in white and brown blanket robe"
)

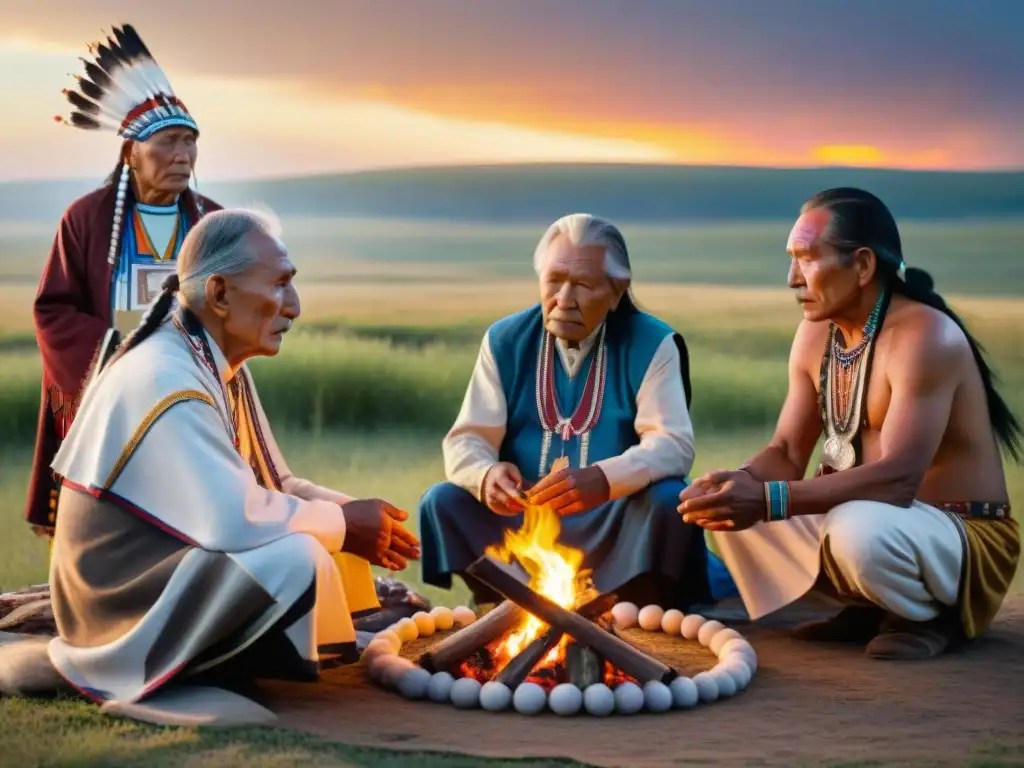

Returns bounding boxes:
[49,205,419,716]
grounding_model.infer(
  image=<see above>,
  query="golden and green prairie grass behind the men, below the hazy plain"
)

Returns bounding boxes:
[0,281,1024,599]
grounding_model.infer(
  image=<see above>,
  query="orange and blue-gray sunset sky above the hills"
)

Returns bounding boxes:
[0,0,1024,179]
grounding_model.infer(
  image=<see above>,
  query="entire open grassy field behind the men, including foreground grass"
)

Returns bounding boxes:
[0,214,1024,767]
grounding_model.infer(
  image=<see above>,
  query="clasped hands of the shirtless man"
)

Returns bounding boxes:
[678,469,766,530]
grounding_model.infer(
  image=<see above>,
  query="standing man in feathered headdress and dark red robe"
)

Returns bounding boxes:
[26,25,220,536]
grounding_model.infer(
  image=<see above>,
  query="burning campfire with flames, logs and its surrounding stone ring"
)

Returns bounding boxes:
[367,462,757,714]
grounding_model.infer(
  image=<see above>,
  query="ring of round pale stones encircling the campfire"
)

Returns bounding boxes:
[361,603,758,717]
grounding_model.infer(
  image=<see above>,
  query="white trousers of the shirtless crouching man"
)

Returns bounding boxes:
[713,501,964,622]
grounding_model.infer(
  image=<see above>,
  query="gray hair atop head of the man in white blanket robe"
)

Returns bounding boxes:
[177,208,281,306]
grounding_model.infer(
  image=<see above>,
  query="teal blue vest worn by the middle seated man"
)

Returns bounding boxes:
[487,304,675,485]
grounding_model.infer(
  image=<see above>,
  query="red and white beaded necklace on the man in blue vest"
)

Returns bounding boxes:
[537,326,608,477]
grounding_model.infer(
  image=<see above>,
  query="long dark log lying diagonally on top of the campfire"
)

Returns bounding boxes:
[468,555,679,685]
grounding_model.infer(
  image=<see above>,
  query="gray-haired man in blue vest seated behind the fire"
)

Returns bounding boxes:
[420,214,720,607]
